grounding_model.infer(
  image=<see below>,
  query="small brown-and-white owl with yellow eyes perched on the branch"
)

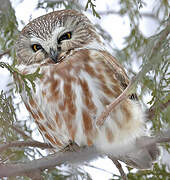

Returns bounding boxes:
[16,10,158,169]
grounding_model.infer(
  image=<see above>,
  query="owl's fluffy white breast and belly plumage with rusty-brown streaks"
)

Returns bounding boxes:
[16,50,143,153]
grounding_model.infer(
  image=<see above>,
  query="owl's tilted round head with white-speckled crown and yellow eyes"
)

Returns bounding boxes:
[16,10,102,64]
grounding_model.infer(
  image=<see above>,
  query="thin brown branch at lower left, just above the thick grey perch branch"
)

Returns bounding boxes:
[0,140,52,152]
